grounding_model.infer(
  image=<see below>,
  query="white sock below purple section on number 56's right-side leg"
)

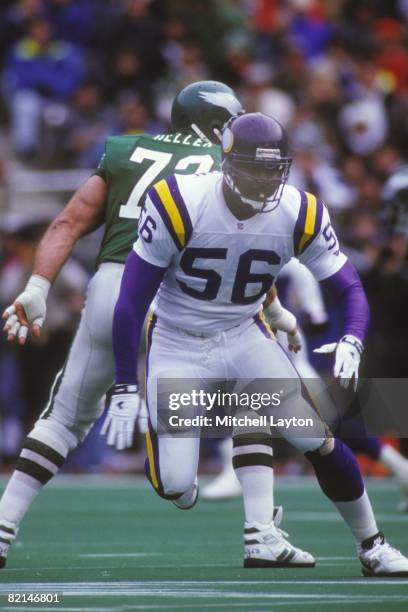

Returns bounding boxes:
[334,490,378,550]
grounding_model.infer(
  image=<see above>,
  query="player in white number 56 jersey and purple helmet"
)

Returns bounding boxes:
[108,113,408,576]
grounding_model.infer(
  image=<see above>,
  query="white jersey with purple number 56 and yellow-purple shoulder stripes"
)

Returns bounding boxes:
[134,172,346,332]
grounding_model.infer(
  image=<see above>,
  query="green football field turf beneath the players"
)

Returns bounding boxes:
[0,476,408,612]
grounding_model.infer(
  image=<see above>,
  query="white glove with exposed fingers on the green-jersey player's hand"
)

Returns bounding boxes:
[3,274,51,344]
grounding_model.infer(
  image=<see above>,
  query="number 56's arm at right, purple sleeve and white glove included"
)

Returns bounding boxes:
[298,201,370,389]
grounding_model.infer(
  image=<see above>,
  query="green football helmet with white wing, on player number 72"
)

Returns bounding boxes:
[171,81,244,144]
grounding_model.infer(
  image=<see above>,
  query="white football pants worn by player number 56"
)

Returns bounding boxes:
[146,315,326,498]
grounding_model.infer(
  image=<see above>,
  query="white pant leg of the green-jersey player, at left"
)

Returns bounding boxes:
[29,263,124,456]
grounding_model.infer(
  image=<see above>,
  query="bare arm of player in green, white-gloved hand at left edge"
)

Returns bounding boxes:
[3,175,107,344]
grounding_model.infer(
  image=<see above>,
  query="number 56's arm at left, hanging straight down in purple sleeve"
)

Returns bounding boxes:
[101,192,177,450]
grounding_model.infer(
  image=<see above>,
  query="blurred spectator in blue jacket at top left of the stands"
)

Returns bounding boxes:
[4,18,85,158]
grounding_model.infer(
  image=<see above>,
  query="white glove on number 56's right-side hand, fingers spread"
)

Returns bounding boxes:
[313,335,363,391]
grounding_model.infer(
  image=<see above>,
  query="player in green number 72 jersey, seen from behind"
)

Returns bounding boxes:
[0,81,304,567]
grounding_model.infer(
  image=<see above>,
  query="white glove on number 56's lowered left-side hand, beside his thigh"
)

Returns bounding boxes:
[101,385,147,450]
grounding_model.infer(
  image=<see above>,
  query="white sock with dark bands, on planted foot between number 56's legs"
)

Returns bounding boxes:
[232,441,273,524]
